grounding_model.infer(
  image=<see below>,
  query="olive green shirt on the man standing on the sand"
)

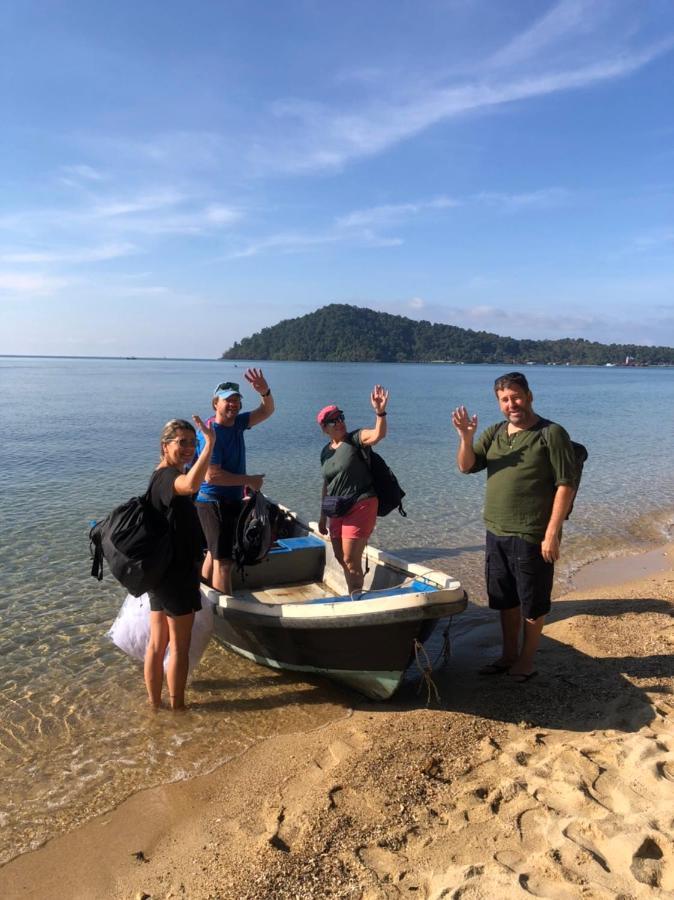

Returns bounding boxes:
[471,419,576,543]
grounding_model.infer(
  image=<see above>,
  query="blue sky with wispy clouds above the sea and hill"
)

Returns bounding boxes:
[0,0,674,357]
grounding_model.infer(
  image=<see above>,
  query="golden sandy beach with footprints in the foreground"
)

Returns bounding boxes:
[0,545,674,900]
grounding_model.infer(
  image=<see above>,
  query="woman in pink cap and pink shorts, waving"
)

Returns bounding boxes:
[316,384,388,593]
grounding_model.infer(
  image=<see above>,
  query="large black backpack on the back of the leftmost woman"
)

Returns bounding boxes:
[89,492,173,597]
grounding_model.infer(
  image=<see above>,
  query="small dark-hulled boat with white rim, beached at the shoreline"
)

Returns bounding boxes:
[201,511,467,699]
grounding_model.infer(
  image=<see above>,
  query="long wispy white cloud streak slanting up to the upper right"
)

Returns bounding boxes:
[251,27,674,174]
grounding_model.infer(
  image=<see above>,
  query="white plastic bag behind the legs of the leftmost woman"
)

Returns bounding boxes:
[107,594,213,672]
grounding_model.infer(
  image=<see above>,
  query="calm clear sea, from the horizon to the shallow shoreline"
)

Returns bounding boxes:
[0,358,674,861]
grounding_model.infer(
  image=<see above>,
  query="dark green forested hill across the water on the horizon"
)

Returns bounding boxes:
[222,303,674,366]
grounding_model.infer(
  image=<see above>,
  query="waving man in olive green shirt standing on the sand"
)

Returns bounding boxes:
[452,372,576,682]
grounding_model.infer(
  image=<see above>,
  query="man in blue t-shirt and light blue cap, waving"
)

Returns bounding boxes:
[196,369,274,594]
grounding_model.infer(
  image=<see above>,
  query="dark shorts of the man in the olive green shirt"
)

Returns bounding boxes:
[485,531,555,619]
